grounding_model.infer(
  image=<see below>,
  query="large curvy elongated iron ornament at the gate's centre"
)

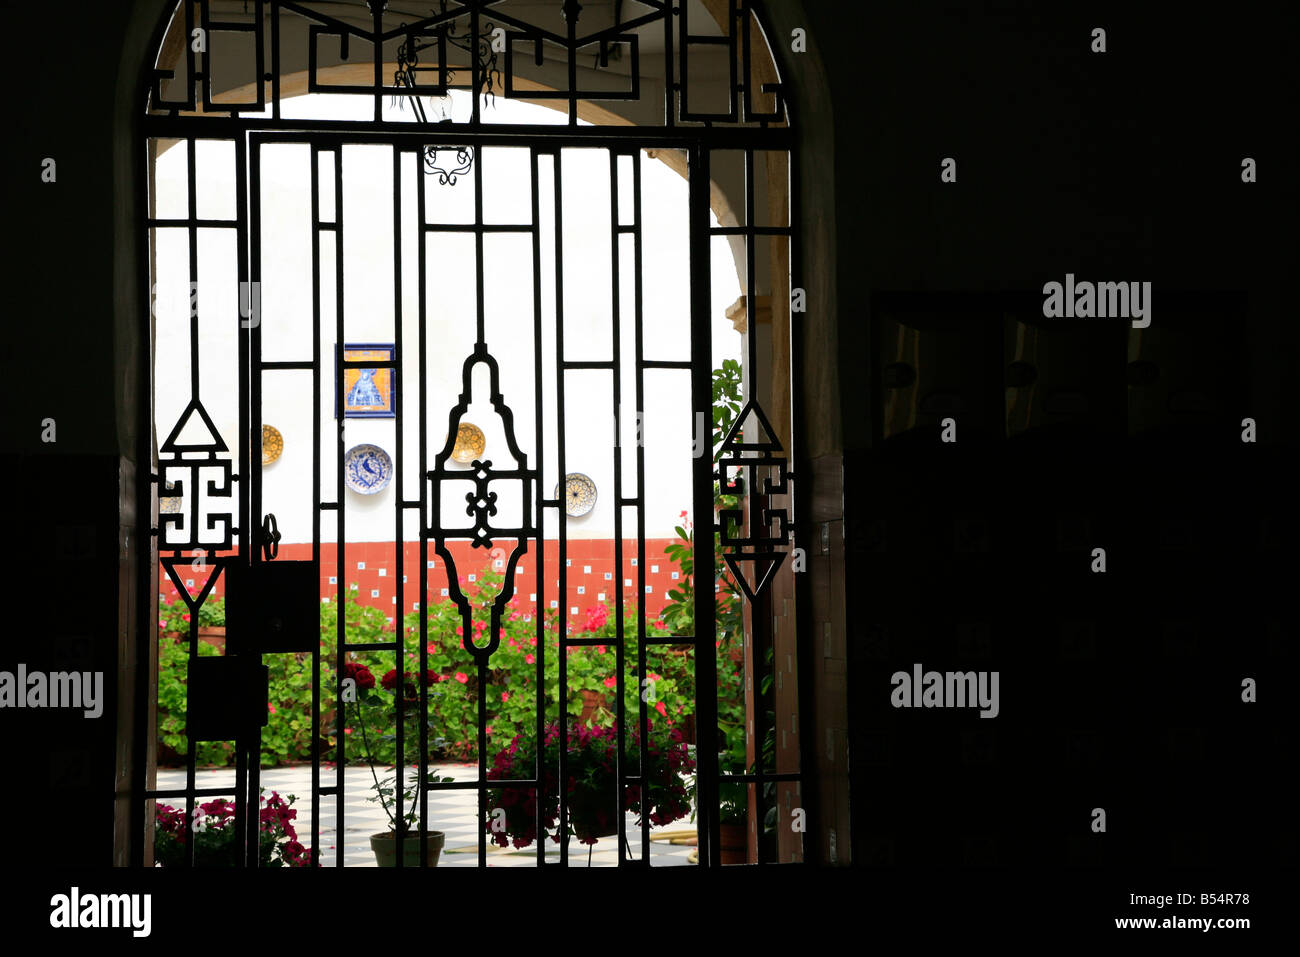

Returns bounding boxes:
[426,341,538,666]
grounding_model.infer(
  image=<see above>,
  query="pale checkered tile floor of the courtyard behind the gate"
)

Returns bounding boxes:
[157,765,696,867]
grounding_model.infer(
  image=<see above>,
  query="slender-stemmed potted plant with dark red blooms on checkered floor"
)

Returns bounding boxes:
[343,662,452,867]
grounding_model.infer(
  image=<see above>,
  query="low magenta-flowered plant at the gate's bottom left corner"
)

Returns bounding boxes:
[153,788,312,867]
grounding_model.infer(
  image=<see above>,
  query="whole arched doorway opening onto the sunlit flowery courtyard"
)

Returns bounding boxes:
[140,1,806,866]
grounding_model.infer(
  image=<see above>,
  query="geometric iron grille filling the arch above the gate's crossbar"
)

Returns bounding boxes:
[150,0,787,127]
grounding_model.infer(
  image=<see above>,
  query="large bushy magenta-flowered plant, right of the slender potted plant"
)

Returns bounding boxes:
[486,722,696,863]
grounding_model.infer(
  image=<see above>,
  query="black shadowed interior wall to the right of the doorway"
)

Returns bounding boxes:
[807,3,1300,875]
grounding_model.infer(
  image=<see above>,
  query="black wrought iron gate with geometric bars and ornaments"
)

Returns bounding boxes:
[146,0,807,867]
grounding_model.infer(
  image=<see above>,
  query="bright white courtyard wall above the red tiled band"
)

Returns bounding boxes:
[155,96,741,542]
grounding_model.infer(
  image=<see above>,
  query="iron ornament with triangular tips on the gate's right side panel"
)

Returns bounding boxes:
[715,399,794,602]
